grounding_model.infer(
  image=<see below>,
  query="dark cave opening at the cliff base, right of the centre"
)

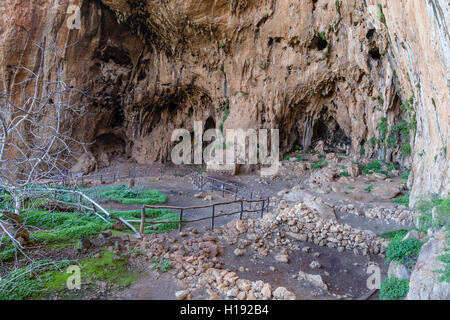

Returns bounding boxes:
[311,116,352,152]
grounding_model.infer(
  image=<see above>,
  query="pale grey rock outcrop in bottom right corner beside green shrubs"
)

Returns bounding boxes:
[406,231,450,300]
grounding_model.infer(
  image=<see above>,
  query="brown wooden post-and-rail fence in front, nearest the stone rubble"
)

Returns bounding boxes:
[139,198,270,234]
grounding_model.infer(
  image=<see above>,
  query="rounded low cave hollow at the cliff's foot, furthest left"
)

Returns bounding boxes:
[92,133,126,169]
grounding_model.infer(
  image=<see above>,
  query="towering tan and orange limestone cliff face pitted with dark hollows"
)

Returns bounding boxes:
[0,0,450,202]
